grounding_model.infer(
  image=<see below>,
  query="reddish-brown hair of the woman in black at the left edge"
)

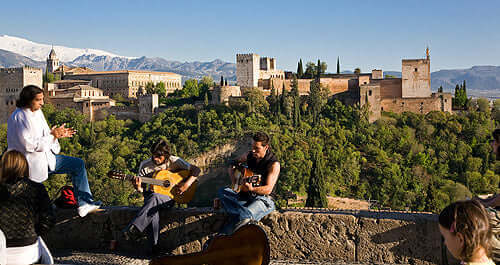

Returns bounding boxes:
[0,150,29,183]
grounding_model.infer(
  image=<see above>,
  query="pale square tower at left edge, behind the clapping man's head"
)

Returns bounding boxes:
[0,66,43,123]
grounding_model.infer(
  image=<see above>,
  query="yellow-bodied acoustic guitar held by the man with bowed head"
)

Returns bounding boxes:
[108,170,197,203]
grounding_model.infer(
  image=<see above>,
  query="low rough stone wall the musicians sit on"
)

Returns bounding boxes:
[46,207,453,264]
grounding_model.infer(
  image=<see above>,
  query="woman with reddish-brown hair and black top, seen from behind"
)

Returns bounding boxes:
[0,150,55,264]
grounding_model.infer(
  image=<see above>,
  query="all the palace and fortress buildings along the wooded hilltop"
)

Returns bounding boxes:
[0,49,452,122]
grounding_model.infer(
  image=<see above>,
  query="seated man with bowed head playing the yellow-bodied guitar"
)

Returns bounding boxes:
[124,139,201,254]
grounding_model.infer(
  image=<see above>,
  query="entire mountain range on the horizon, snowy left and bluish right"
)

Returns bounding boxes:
[0,35,500,97]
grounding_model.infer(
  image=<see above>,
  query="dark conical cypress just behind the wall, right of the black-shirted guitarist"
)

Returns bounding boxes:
[306,147,328,208]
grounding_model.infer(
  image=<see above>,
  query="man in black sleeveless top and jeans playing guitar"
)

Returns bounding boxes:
[218,132,280,234]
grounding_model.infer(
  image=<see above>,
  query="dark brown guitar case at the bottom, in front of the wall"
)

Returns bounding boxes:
[150,224,270,265]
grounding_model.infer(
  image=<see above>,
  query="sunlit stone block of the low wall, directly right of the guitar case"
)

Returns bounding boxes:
[261,212,356,261]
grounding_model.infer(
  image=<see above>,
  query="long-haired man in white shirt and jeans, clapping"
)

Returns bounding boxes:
[7,85,100,217]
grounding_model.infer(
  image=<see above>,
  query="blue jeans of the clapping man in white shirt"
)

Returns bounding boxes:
[49,155,94,206]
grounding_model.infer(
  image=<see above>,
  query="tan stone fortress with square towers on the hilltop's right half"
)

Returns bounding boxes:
[230,49,452,121]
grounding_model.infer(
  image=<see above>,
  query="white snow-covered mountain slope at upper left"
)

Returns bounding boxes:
[0,35,132,62]
